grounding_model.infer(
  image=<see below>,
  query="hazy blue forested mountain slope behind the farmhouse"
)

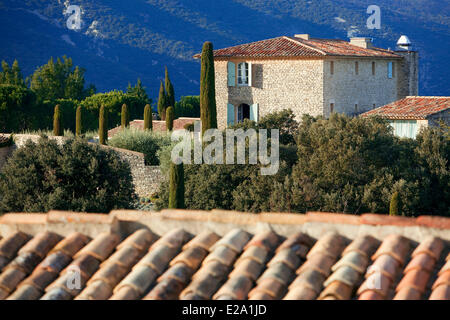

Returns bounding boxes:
[0,0,450,97]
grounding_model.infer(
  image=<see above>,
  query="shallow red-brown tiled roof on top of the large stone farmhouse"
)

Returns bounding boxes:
[194,36,400,58]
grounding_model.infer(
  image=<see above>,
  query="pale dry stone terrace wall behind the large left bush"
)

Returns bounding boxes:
[0,134,163,198]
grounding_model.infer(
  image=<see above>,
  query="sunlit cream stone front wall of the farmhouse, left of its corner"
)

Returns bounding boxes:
[214,59,323,129]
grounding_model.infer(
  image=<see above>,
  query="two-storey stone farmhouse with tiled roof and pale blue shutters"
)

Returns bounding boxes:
[194,34,418,129]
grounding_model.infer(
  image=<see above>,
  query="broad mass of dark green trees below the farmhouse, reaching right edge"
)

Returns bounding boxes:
[158,112,450,216]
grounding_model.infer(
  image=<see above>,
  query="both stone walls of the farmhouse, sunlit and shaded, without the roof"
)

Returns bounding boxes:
[215,55,417,129]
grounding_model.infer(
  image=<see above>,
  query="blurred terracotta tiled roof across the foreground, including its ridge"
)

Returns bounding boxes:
[0,211,450,300]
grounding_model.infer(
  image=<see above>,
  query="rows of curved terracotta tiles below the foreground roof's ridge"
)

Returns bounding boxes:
[0,213,450,300]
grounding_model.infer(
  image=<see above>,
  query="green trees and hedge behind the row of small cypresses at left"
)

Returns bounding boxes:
[0,57,151,132]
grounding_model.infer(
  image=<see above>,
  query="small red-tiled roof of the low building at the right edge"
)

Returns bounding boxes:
[361,96,450,120]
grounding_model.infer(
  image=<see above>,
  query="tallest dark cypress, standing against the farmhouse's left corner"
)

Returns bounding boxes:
[200,42,217,134]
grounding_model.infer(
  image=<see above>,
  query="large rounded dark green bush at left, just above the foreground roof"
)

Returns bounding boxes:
[0,138,136,213]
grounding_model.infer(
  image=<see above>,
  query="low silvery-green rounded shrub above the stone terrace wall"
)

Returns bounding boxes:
[109,129,171,165]
